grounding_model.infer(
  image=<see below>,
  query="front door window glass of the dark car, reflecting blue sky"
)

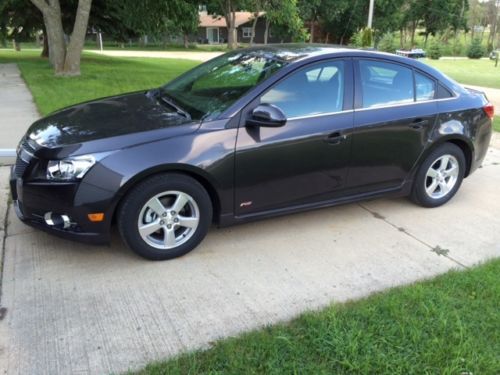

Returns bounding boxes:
[261,61,344,118]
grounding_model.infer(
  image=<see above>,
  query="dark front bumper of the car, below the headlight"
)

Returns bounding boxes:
[10,167,110,244]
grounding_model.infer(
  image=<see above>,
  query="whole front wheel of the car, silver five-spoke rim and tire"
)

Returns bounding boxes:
[117,173,212,260]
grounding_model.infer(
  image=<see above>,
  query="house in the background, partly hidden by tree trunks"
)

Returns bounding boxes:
[196,11,288,44]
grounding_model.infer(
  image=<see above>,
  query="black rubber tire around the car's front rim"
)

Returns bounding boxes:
[117,173,213,260]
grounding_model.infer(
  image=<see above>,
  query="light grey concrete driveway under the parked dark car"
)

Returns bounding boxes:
[0,148,500,374]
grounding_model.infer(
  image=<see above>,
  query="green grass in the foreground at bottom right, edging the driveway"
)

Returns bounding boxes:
[135,260,500,375]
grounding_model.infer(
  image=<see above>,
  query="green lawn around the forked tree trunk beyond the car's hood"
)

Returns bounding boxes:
[0,50,198,115]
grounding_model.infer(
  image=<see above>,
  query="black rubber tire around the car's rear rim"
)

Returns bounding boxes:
[410,143,466,207]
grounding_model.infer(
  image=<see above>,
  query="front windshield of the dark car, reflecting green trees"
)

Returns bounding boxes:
[161,51,287,120]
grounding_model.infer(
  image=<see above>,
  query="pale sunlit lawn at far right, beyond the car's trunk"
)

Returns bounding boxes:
[422,59,500,89]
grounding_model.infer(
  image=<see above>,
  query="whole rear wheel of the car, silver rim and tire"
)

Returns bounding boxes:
[411,143,466,207]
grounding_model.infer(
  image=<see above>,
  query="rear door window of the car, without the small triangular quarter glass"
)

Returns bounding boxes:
[359,60,414,108]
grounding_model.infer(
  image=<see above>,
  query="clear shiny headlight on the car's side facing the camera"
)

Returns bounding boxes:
[47,155,96,181]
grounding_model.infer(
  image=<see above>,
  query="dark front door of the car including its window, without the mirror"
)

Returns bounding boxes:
[235,59,353,216]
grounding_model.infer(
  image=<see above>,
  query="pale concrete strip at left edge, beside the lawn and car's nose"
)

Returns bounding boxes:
[0,64,40,149]
